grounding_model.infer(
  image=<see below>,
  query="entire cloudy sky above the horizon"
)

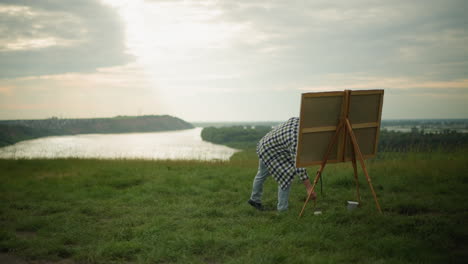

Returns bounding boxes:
[0,0,468,122]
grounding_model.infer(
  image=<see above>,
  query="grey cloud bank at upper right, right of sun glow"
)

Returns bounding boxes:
[211,1,468,79]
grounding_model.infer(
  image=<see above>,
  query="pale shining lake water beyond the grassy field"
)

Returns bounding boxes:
[0,128,238,160]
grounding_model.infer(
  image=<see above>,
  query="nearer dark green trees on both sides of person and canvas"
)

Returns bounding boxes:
[202,126,468,152]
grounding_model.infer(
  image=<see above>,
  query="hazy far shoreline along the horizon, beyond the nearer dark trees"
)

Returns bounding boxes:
[0,115,468,147]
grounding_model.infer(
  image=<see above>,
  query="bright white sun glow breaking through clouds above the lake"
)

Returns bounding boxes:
[99,0,261,115]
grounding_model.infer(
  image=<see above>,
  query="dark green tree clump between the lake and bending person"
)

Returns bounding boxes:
[201,126,271,149]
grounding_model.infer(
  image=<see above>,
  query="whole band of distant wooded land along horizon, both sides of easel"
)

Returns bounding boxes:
[0,115,468,151]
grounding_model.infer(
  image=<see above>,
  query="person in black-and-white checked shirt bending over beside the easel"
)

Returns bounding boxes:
[248,117,317,211]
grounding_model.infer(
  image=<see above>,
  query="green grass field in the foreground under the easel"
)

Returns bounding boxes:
[0,150,468,263]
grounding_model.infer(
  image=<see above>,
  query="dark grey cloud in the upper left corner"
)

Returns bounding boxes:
[0,0,133,78]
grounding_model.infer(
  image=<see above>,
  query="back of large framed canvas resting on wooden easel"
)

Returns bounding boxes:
[296,90,383,167]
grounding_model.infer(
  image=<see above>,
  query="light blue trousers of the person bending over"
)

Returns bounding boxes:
[250,159,292,211]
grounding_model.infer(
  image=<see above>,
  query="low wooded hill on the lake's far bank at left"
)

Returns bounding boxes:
[0,115,193,146]
